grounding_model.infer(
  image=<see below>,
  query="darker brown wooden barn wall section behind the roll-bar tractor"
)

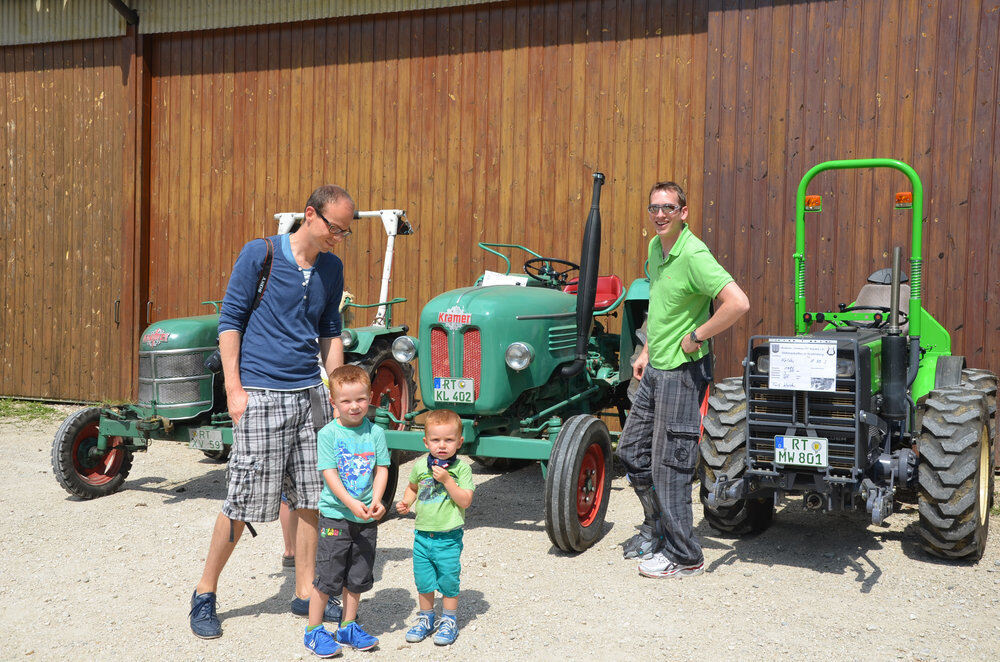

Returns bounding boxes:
[702,0,1000,382]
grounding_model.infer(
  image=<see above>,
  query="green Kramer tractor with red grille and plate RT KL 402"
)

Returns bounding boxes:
[375,173,649,551]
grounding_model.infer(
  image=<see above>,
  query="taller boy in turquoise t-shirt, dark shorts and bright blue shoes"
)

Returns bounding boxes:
[305,365,389,657]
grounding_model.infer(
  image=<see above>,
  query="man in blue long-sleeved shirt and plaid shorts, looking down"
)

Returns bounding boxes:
[189,185,354,639]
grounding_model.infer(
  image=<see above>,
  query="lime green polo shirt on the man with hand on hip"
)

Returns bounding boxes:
[646,223,733,370]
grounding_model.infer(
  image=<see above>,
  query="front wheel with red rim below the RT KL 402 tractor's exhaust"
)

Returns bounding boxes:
[545,414,611,552]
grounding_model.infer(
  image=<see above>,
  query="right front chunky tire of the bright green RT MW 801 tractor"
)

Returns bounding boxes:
[917,386,993,560]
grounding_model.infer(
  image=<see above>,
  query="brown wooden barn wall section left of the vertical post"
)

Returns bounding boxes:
[0,39,141,400]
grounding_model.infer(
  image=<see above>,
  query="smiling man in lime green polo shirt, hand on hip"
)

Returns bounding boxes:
[617,182,750,577]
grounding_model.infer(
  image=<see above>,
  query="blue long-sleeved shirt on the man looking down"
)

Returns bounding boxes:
[219,234,344,391]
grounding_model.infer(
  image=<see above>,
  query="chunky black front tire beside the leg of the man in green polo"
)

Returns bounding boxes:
[698,377,774,535]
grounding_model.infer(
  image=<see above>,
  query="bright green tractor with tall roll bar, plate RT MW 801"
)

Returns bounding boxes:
[698,159,997,559]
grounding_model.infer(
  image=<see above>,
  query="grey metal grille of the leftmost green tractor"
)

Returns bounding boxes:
[139,347,215,417]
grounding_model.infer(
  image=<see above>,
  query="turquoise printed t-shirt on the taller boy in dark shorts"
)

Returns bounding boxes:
[316,418,389,522]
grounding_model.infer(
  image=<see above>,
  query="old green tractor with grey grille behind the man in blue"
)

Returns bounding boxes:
[52,209,416,499]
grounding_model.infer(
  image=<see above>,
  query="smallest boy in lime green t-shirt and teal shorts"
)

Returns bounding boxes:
[396,409,475,646]
